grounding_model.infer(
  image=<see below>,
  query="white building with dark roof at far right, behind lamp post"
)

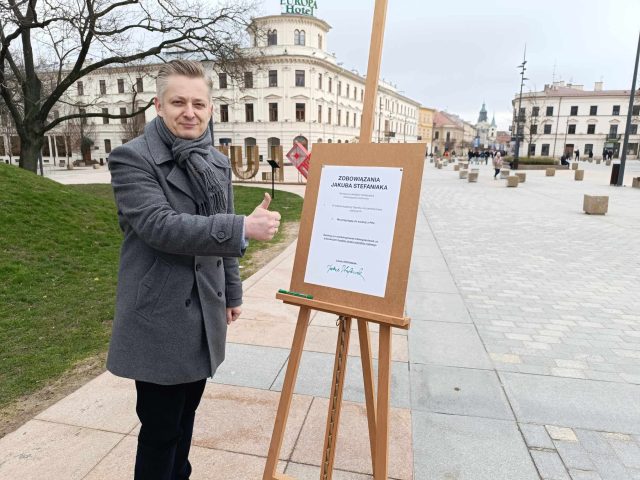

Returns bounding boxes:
[512,82,640,159]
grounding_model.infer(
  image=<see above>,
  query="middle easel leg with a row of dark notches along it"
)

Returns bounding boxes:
[320,317,351,480]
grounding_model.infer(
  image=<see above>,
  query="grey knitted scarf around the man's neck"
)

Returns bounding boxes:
[153,117,227,217]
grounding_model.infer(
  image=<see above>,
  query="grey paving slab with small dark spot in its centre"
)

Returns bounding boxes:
[411,364,513,420]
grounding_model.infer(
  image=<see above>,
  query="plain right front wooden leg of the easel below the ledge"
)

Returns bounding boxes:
[373,325,391,480]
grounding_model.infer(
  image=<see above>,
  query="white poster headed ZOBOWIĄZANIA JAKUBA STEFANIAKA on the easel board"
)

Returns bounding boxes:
[304,165,402,297]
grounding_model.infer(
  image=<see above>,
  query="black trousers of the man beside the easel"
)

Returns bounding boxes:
[135,380,206,480]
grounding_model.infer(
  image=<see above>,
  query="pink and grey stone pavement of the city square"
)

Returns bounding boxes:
[0,161,640,480]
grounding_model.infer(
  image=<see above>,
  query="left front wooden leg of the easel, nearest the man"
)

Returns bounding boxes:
[262,307,311,480]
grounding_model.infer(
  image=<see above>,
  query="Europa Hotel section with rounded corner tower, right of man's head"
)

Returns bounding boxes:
[214,15,420,158]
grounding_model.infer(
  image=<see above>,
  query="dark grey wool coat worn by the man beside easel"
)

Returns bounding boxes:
[107,122,245,385]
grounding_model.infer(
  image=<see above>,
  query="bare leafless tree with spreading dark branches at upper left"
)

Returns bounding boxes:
[0,0,255,172]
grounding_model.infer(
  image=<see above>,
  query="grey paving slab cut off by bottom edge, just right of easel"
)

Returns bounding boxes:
[412,411,539,480]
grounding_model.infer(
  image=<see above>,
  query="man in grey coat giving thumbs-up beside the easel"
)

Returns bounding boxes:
[107,60,280,480]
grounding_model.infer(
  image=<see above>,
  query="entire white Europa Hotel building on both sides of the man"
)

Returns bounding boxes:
[0,14,420,164]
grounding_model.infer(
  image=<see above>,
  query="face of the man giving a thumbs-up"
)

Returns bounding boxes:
[155,75,213,140]
